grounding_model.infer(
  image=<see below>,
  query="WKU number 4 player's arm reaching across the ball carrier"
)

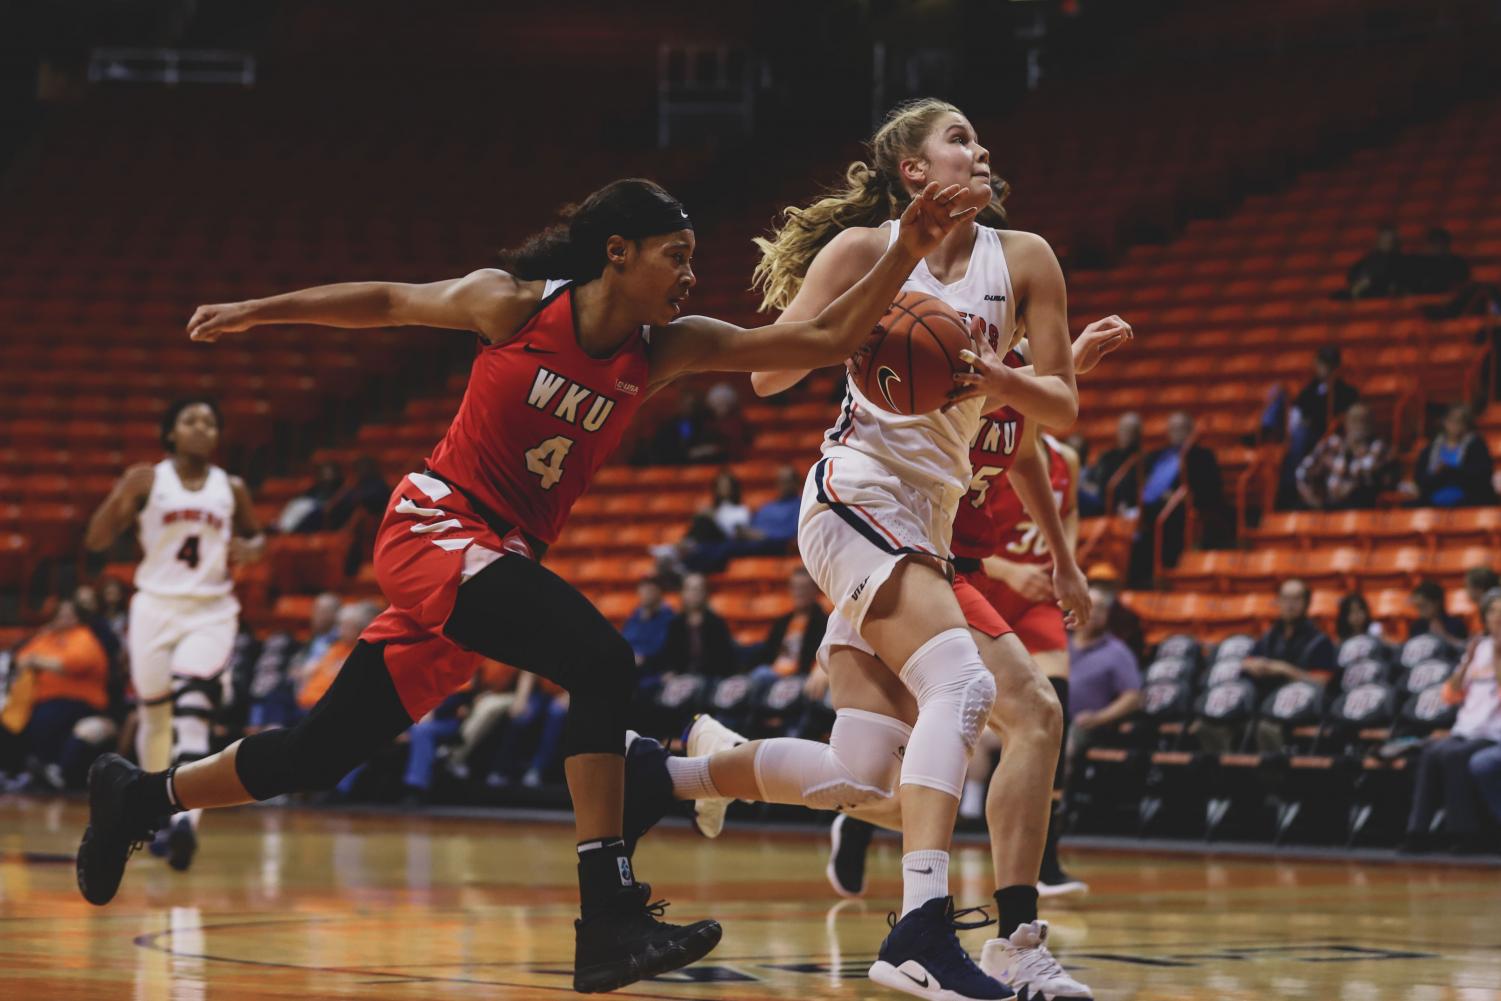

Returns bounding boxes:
[651,183,976,386]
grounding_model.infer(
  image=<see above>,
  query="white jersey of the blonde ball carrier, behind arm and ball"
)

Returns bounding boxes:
[823,222,1016,515]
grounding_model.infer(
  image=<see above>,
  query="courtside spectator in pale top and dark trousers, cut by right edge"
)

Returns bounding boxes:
[1402,590,1501,851]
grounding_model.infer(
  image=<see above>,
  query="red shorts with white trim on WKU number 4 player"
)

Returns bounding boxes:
[360,473,530,720]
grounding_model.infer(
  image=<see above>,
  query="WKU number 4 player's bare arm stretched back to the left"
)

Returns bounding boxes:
[188,269,542,342]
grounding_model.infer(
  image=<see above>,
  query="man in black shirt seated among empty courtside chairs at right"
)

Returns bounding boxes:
[1196,578,1334,753]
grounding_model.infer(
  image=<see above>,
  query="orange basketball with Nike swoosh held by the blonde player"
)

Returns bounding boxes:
[850,293,970,416]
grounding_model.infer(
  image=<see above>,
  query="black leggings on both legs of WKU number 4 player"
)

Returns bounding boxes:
[236,554,636,800]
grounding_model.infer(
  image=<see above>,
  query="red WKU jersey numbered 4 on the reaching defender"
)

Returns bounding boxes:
[428,284,647,545]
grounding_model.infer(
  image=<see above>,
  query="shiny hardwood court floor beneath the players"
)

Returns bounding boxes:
[0,798,1501,1001]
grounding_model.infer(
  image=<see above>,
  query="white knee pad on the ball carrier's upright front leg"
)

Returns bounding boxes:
[901,629,995,797]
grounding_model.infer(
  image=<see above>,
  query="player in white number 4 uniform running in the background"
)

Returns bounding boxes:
[84,399,266,870]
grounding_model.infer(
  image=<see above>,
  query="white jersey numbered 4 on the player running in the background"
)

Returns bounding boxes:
[135,459,234,597]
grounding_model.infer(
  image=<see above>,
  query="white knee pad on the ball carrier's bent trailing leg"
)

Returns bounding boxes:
[755,708,913,810]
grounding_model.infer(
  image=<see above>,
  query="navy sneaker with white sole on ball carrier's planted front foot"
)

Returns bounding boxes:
[871,897,1016,1001]
